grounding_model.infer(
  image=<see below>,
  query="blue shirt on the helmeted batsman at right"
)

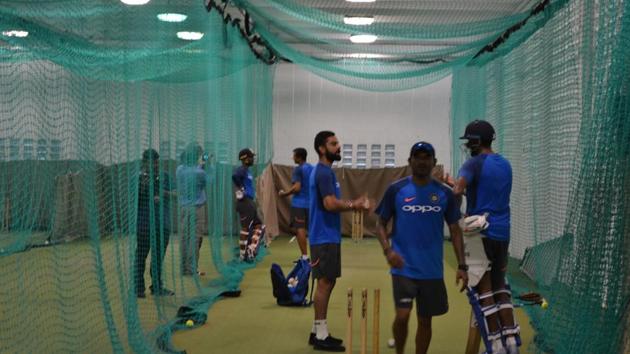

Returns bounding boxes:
[459,154,512,241]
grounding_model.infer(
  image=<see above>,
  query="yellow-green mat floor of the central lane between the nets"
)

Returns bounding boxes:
[173,236,534,354]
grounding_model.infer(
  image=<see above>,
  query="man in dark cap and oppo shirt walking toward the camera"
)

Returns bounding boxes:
[376,142,468,354]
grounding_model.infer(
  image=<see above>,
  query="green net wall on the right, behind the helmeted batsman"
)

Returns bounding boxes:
[452,0,630,353]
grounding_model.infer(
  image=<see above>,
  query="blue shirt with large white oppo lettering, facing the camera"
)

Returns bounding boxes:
[376,176,461,279]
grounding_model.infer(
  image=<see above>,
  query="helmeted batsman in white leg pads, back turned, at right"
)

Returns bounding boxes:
[450,120,519,353]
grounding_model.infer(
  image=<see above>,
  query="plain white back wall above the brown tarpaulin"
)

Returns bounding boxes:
[273,64,451,171]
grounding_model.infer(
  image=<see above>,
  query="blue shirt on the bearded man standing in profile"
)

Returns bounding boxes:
[308,163,341,245]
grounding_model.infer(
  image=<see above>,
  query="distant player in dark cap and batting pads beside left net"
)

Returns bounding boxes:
[232,148,262,261]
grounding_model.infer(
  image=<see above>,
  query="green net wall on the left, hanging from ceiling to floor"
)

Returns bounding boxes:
[0,0,273,353]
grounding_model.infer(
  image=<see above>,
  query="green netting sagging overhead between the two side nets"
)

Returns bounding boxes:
[234,0,567,91]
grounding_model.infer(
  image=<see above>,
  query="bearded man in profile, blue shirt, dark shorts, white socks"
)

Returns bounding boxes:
[308,131,369,352]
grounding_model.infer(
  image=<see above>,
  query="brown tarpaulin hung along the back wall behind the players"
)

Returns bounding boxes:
[258,165,410,236]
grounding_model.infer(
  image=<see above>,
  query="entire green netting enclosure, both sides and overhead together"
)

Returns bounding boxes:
[0,0,630,353]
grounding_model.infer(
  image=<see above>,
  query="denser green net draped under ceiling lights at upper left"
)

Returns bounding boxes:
[0,0,256,82]
